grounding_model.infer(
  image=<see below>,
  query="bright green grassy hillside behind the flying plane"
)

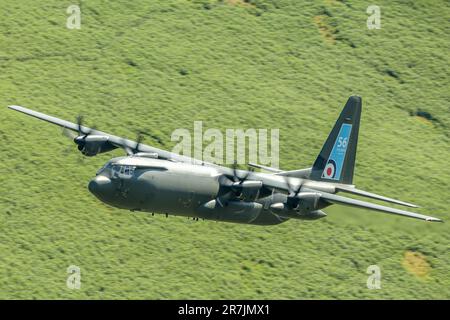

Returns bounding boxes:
[0,0,450,299]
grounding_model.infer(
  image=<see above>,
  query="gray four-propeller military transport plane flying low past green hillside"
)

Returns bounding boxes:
[9,96,442,225]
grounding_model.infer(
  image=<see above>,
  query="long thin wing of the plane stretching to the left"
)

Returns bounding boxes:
[8,106,209,166]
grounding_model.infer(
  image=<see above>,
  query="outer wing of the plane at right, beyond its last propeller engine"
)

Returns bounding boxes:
[320,192,443,222]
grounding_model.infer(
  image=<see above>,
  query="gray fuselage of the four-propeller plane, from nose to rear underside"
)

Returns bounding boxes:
[88,156,326,225]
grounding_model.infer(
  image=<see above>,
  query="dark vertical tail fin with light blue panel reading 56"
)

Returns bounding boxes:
[310,96,361,184]
